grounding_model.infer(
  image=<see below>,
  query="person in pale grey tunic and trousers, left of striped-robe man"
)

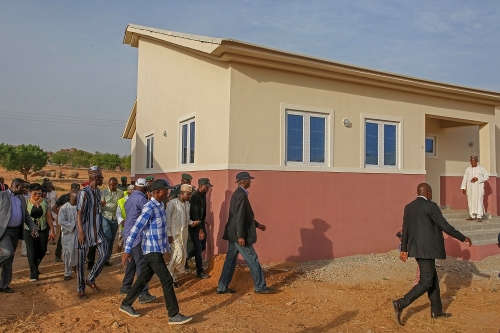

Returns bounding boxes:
[58,189,78,281]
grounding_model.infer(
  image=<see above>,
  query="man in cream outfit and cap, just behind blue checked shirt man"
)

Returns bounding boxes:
[167,184,193,288]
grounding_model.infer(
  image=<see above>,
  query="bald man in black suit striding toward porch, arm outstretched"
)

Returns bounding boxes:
[392,183,472,325]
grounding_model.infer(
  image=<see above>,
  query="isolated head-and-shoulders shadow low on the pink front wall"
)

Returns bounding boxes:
[287,218,333,262]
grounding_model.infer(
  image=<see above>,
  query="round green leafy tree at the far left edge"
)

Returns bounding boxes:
[0,143,47,181]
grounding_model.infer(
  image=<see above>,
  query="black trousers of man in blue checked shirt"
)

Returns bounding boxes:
[122,252,179,317]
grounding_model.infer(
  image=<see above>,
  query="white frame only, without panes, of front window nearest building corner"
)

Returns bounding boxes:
[284,109,330,167]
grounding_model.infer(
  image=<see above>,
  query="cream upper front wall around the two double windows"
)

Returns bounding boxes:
[229,63,494,173]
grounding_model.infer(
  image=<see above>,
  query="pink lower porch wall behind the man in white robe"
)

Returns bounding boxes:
[440,176,500,215]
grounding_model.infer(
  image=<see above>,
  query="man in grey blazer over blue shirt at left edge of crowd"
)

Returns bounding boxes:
[0,178,38,293]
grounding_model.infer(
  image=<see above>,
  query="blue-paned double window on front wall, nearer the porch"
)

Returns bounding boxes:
[365,120,399,168]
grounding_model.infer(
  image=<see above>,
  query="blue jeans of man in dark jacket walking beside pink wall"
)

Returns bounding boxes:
[217,242,267,291]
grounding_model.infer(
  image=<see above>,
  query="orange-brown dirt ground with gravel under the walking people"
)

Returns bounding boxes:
[0,246,500,333]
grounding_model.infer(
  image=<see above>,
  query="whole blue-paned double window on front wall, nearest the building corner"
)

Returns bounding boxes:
[285,111,328,165]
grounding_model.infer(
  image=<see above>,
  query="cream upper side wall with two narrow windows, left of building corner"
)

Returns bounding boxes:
[135,38,230,174]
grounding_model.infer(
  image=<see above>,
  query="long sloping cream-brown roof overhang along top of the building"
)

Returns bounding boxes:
[123,24,500,106]
